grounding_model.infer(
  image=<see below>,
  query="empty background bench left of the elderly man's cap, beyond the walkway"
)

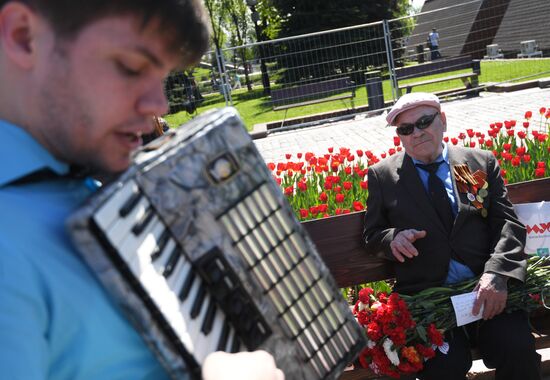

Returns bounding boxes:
[271,77,355,122]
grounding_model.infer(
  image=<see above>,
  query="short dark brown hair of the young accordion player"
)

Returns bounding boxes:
[0,0,209,66]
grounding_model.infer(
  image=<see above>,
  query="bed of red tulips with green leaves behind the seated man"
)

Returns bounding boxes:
[268,107,550,221]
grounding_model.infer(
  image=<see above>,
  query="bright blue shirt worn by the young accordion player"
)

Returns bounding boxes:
[0,120,171,380]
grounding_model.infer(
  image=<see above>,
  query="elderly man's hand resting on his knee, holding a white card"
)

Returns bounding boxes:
[472,273,508,320]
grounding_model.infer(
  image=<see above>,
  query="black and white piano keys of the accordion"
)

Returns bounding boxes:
[94,181,245,363]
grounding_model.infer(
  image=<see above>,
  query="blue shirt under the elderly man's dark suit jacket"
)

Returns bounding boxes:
[411,144,474,284]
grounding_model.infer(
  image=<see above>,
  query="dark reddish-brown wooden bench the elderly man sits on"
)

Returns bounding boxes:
[302,178,550,380]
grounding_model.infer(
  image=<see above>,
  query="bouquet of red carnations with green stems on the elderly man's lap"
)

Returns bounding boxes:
[353,257,550,378]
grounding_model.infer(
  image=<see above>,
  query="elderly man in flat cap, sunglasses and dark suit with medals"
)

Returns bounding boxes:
[363,93,540,380]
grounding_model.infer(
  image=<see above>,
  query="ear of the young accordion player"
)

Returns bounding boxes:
[0,1,37,69]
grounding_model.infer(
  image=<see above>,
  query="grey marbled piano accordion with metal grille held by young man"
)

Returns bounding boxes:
[68,108,365,379]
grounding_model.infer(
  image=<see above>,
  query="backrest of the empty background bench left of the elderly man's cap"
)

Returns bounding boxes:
[271,77,355,106]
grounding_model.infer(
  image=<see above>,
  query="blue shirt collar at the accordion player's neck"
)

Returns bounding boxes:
[0,120,69,187]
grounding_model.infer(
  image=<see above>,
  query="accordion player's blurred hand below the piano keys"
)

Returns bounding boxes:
[202,351,285,380]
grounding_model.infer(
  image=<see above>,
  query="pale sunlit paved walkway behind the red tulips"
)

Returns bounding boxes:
[255,88,550,162]
